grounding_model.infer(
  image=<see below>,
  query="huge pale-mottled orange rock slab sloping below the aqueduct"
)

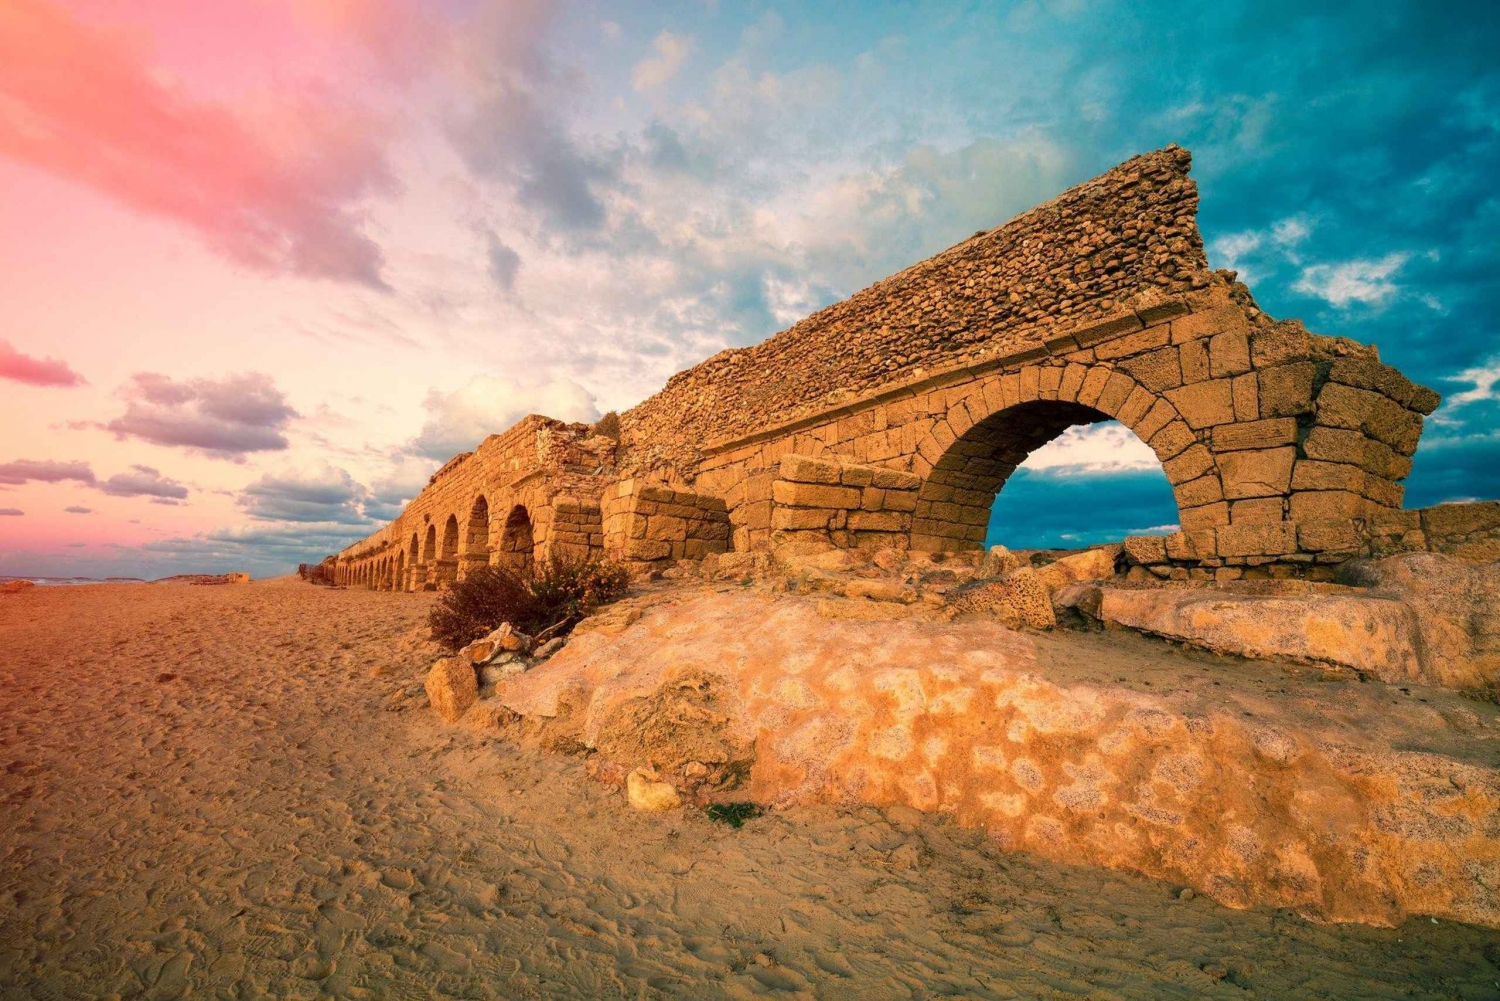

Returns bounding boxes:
[500,590,1500,926]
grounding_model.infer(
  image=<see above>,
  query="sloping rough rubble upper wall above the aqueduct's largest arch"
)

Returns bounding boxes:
[621,146,1209,468]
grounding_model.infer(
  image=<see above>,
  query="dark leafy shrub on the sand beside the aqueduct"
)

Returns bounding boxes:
[428,557,630,650]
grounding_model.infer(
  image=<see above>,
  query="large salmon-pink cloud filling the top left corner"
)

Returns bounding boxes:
[0,0,395,287]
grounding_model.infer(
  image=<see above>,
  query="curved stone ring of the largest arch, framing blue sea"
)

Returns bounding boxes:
[912,365,1223,551]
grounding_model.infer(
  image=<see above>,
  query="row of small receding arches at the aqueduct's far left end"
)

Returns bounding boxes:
[339,494,536,591]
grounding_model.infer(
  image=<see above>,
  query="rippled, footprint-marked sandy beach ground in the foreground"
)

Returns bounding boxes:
[0,579,1500,999]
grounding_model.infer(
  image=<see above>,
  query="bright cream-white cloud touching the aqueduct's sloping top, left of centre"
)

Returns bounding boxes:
[410,375,599,461]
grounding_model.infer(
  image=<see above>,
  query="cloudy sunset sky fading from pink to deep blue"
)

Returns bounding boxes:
[0,0,1500,576]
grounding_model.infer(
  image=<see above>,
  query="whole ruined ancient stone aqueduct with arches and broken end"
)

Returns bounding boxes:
[330,147,1464,590]
